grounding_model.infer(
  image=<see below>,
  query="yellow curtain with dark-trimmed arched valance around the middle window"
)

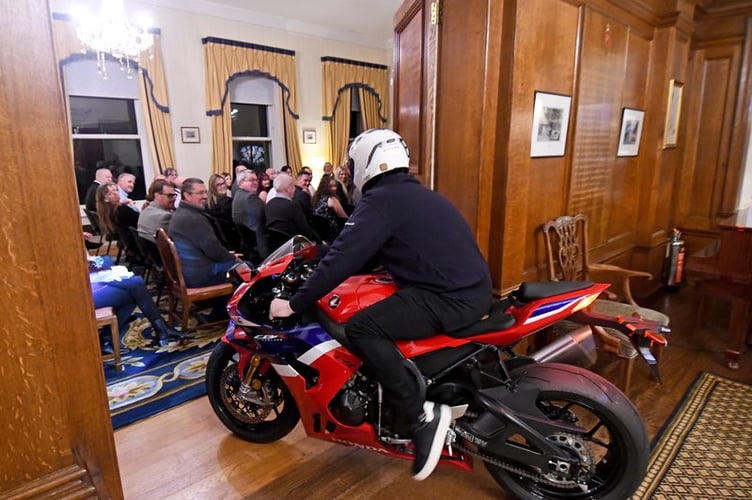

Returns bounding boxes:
[202,37,301,173]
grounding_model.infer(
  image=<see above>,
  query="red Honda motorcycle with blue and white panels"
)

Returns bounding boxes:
[206,236,667,499]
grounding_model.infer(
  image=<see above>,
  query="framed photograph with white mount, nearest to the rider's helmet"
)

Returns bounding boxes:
[530,91,572,158]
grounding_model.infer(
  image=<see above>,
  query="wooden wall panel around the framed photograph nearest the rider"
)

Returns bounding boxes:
[512,0,580,288]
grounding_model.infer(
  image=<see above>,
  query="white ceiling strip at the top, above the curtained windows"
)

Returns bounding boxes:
[147,0,404,48]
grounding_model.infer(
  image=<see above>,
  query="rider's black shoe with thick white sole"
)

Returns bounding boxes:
[413,401,452,481]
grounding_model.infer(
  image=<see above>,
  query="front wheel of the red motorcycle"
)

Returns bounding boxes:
[206,342,300,443]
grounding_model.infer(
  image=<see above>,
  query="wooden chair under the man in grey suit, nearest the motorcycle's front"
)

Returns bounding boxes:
[157,228,233,332]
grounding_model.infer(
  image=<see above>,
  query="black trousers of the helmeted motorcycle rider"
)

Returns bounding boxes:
[345,288,491,424]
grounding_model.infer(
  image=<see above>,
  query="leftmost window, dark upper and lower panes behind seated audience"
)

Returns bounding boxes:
[70,96,146,204]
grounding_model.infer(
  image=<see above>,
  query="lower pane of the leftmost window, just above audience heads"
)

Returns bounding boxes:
[73,139,146,205]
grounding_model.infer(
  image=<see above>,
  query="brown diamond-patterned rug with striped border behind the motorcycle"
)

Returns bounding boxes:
[633,372,752,499]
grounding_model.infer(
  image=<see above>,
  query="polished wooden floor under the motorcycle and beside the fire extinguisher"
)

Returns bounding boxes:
[115,289,752,500]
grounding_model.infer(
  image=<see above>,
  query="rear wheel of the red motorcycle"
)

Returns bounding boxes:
[484,363,649,500]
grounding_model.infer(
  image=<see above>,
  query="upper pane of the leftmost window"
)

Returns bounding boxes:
[70,96,138,135]
